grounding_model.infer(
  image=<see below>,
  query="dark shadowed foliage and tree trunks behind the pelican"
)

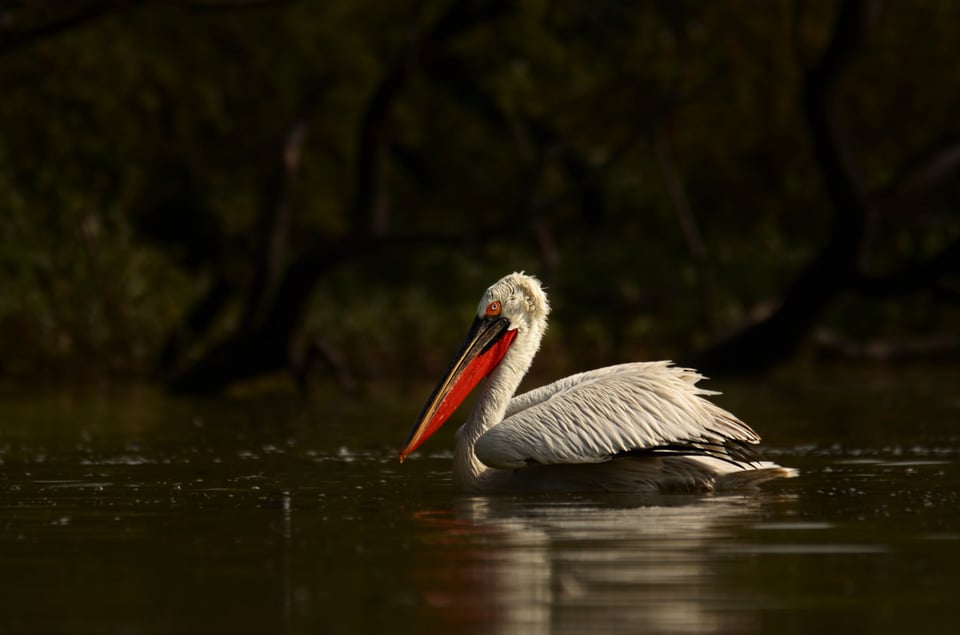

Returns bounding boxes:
[0,0,960,391]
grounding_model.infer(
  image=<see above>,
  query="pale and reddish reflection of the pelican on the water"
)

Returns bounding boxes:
[419,496,790,633]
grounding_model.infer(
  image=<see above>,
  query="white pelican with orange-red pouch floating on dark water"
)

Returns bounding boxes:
[400,273,796,493]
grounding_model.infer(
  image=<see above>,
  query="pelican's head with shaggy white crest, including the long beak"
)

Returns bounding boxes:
[400,272,550,462]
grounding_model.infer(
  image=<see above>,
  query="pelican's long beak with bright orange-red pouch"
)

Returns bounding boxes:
[400,317,517,463]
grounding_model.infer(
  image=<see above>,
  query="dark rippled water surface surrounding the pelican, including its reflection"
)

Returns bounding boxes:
[0,368,960,634]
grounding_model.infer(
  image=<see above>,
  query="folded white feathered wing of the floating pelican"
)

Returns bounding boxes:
[475,362,760,469]
